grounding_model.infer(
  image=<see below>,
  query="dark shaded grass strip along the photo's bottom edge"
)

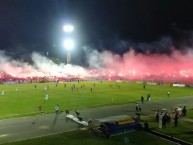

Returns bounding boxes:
[0,130,174,145]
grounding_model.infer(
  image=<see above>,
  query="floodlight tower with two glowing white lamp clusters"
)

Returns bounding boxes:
[63,25,74,64]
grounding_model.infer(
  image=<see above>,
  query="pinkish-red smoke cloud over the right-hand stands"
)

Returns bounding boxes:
[88,51,193,83]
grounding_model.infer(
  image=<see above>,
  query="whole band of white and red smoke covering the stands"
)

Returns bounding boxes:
[0,51,193,83]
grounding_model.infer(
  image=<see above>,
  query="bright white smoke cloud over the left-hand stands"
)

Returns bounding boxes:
[0,51,88,78]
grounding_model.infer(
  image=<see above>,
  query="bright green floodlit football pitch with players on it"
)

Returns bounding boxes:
[0,82,193,119]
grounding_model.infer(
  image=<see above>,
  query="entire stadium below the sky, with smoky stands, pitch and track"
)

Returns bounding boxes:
[0,34,193,144]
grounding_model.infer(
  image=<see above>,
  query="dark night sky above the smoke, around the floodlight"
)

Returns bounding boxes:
[0,0,193,62]
